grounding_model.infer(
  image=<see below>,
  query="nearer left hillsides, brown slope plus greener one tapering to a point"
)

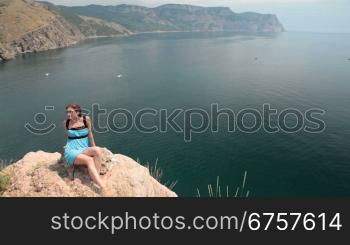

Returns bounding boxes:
[0,0,131,61]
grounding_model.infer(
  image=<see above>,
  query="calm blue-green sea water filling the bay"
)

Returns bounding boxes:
[0,33,350,197]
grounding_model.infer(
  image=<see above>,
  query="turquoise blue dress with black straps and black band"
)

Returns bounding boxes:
[64,116,89,166]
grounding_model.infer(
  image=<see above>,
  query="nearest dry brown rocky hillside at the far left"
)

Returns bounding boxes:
[0,0,82,60]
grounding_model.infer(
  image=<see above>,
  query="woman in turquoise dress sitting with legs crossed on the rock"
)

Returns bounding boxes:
[64,104,107,195]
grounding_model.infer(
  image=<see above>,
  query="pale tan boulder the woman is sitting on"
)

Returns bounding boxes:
[2,148,177,197]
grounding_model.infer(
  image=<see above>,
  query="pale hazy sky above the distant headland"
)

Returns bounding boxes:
[48,0,350,33]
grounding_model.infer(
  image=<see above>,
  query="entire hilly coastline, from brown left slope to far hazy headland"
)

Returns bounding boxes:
[0,0,285,62]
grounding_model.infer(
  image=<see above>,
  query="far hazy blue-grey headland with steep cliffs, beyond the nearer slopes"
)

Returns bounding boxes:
[65,4,284,32]
